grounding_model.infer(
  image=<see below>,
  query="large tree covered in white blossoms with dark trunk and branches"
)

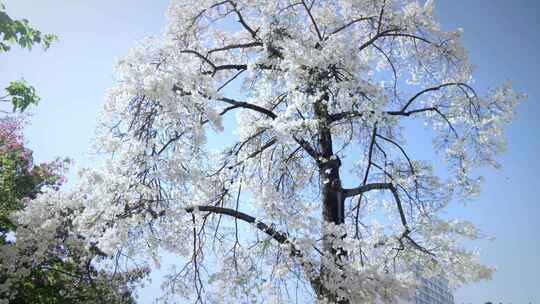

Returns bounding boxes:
[21,0,523,303]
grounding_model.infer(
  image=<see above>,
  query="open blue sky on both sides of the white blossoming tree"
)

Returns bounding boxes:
[0,0,540,304]
